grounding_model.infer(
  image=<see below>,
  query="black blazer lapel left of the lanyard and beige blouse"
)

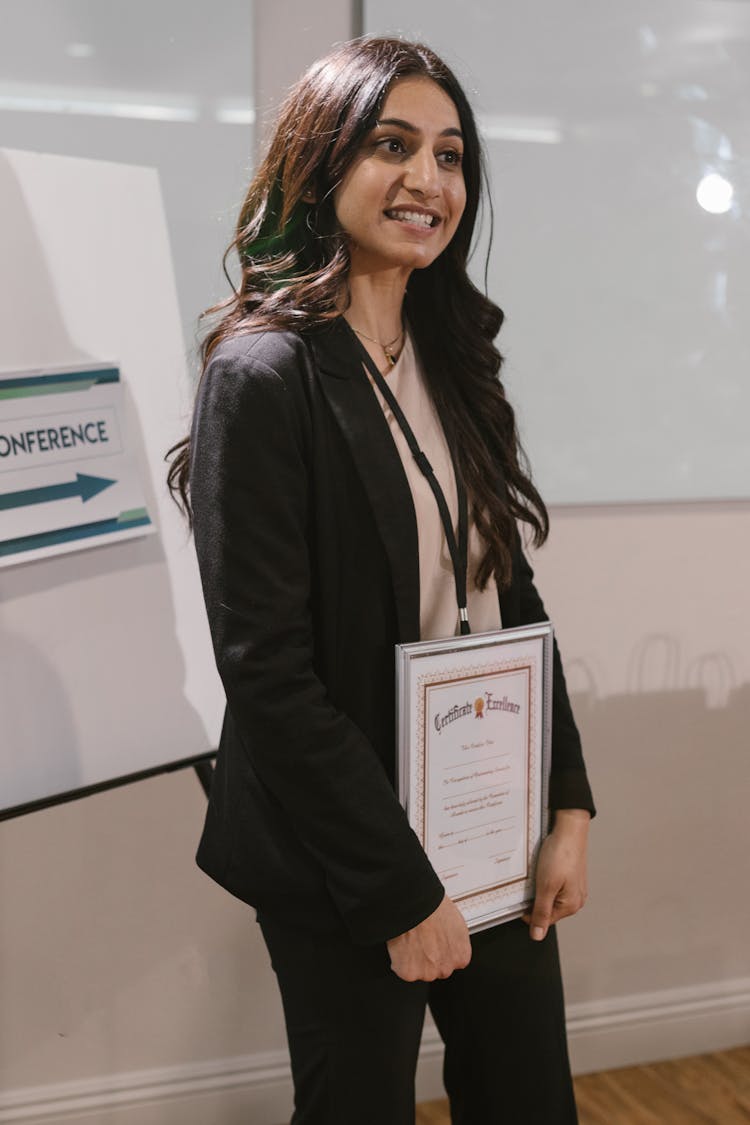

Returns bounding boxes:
[308,317,419,642]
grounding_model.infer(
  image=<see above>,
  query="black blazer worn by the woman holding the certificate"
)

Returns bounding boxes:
[191,320,593,944]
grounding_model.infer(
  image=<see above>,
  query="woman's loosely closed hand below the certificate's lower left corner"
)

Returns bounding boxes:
[387,894,471,981]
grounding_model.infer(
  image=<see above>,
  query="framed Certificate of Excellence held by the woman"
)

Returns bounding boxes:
[396,622,552,933]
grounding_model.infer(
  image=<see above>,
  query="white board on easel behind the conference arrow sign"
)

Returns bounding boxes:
[0,150,224,810]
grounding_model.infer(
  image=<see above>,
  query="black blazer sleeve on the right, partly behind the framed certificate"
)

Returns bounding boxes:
[517,545,596,817]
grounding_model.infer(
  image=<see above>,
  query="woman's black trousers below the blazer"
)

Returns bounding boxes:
[257,915,578,1125]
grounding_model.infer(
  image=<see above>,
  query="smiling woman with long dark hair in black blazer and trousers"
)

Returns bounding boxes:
[170,39,593,1125]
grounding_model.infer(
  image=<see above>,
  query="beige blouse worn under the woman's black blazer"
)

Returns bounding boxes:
[368,334,500,640]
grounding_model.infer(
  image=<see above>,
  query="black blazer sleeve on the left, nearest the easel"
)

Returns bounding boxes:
[191,338,444,944]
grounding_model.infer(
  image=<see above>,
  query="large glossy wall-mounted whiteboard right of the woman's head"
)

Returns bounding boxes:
[364,0,750,504]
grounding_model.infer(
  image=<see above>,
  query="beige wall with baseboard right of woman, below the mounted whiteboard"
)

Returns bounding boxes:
[536,504,750,1069]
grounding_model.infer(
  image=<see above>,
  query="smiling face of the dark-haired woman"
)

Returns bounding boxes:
[334,77,467,273]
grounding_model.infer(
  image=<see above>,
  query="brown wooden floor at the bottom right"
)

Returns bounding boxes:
[417,1046,750,1125]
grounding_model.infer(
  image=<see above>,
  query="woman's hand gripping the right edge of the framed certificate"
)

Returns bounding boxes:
[523,809,591,942]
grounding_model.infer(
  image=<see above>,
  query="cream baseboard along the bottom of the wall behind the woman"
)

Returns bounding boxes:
[0,978,750,1125]
